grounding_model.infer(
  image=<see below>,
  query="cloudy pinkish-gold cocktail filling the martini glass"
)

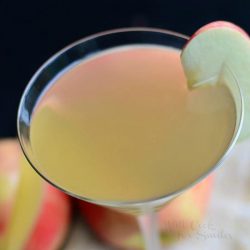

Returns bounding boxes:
[30,45,236,201]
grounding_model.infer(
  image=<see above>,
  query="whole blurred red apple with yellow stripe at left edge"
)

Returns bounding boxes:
[0,139,71,250]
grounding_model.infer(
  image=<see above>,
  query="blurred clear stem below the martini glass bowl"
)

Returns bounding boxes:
[137,210,161,250]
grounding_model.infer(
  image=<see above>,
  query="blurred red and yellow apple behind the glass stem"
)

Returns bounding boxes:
[78,176,213,249]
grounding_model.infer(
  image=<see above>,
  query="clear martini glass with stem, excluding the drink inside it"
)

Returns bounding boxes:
[17,28,244,250]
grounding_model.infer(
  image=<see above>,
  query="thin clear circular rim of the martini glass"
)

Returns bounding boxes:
[17,27,244,209]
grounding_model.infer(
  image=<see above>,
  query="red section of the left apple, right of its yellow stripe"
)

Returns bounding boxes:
[25,184,70,250]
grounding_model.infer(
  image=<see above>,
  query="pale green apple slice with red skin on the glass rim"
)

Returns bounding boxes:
[181,21,250,140]
